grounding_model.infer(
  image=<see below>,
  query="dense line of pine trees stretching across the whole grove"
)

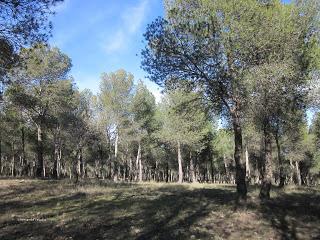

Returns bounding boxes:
[0,0,320,199]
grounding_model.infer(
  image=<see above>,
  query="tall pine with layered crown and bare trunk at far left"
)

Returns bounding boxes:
[7,45,71,177]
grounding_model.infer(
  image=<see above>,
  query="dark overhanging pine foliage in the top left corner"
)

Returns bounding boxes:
[0,0,63,91]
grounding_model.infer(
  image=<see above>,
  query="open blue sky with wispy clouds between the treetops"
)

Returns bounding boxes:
[50,0,163,100]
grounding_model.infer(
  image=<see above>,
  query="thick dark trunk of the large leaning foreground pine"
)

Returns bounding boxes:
[232,114,247,201]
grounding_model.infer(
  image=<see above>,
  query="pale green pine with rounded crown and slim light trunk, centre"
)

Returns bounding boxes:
[159,90,208,183]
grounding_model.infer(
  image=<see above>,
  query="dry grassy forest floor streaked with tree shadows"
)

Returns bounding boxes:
[0,180,320,240]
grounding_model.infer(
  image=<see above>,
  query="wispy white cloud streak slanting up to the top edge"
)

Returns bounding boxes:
[103,0,148,53]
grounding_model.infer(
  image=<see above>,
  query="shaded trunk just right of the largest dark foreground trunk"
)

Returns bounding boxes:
[259,123,272,199]
